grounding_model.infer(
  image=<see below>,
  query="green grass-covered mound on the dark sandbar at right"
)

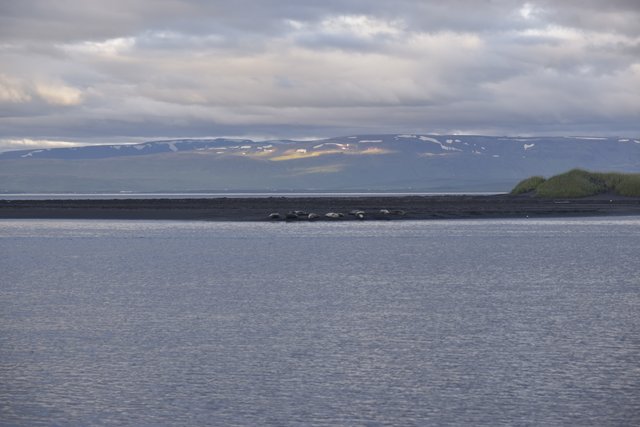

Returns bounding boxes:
[511,169,640,198]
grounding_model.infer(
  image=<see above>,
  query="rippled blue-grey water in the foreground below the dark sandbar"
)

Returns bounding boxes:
[0,217,640,426]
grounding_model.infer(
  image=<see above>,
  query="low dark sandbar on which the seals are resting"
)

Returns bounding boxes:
[0,194,640,221]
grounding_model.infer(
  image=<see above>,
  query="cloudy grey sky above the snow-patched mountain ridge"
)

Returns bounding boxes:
[0,0,640,150]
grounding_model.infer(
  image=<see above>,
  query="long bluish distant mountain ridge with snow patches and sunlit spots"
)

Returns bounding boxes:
[0,135,640,192]
